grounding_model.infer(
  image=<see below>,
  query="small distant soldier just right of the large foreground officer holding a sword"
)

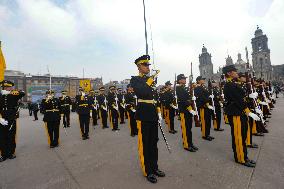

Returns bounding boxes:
[163,81,177,134]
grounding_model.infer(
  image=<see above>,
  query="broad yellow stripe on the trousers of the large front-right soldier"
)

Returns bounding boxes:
[233,116,245,163]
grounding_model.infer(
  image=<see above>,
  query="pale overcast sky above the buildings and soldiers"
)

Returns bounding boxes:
[0,0,284,83]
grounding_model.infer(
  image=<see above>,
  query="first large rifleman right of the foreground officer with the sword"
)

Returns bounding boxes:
[176,74,198,152]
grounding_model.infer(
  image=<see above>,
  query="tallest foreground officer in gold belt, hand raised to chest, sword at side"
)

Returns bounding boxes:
[130,55,165,183]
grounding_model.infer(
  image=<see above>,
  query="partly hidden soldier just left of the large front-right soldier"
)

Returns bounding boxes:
[211,80,224,131]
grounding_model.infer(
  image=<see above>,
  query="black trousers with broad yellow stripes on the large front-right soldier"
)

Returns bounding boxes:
[228,115,248,163]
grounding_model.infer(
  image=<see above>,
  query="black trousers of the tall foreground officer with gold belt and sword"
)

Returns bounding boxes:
[137,120,158,176]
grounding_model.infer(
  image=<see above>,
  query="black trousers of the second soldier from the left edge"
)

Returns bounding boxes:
[46,120,60,146]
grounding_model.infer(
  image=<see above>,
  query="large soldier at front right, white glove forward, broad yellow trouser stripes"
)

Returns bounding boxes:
[223,65,260,167]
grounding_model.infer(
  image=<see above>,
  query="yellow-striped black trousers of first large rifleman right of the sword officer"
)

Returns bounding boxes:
[180,112,192,149]
